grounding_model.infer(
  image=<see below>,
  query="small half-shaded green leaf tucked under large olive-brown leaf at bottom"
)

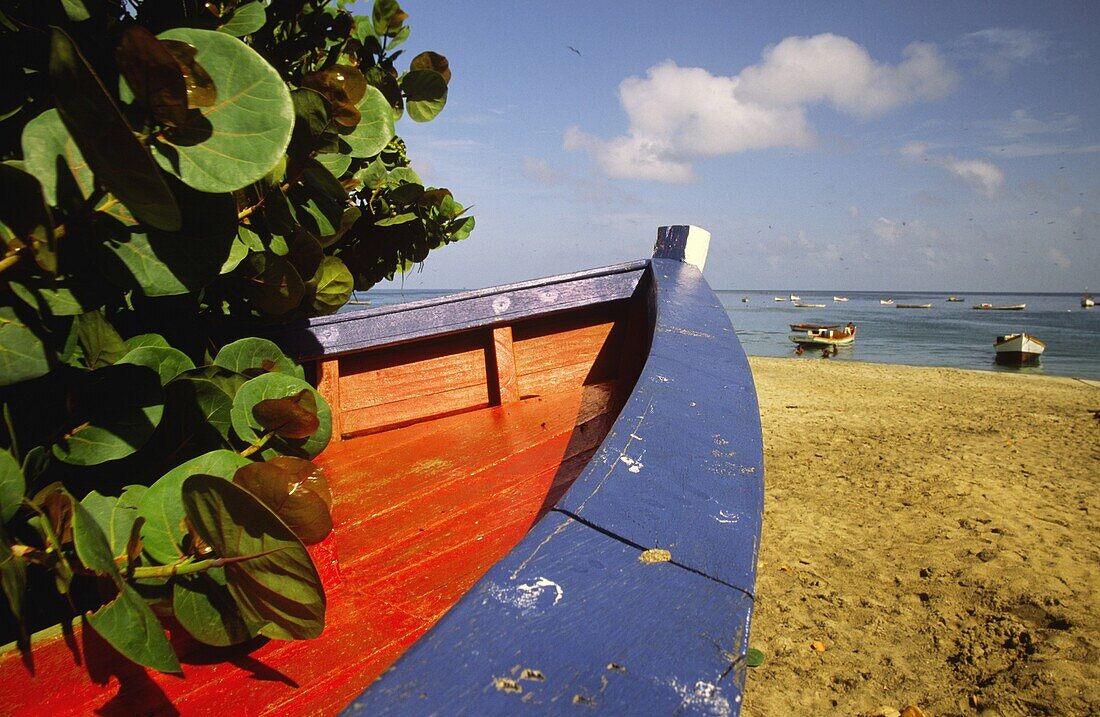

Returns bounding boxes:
[172,567,254,647]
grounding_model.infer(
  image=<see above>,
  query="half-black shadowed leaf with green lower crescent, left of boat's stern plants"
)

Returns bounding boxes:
[53,364,164,465]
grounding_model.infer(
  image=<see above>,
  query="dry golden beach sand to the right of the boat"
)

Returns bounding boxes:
[743,359,1100,717]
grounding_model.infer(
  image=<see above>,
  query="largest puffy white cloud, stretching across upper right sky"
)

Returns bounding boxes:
[564,34,956,183]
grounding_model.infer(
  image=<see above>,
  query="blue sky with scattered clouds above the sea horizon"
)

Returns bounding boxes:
[369,0,1100,291]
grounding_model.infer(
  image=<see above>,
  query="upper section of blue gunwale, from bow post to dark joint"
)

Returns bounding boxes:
[558,260,763,593]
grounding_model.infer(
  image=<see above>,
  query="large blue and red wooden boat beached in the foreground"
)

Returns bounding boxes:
[0,227,763,716]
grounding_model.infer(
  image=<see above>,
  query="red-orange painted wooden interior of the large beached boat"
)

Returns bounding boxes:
[0,297,649,716]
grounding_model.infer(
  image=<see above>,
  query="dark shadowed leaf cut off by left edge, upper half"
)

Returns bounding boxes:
[0,163,57,274]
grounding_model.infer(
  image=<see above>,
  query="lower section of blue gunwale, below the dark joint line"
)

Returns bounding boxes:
[343,512,752,715]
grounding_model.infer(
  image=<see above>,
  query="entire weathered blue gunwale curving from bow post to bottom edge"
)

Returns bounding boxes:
[344,245,763,715]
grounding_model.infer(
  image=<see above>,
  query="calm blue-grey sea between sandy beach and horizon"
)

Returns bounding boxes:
[349,289,1100,379]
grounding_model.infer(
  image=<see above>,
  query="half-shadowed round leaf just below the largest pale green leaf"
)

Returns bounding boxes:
[92,180,237,296]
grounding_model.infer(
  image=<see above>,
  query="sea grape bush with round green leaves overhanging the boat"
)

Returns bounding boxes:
[0,0,474,671]
